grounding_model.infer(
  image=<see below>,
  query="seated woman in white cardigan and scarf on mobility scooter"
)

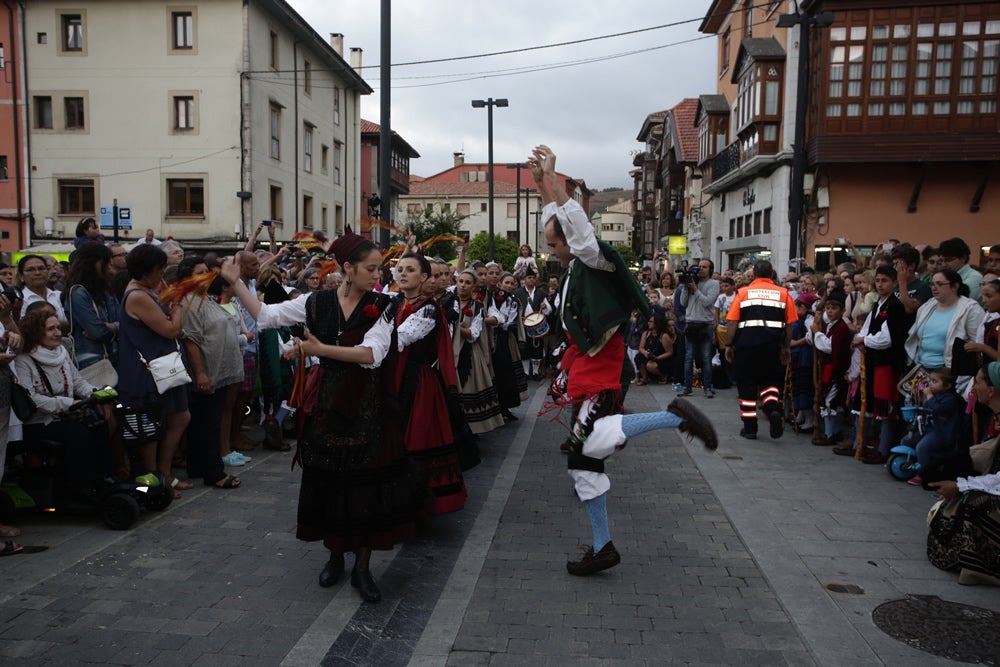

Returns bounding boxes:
[14,309,115,500]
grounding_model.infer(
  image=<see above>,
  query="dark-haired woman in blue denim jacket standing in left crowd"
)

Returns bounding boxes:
[62,243,121,370]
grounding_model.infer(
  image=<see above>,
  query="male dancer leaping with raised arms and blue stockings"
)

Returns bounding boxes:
[528,146,718,576]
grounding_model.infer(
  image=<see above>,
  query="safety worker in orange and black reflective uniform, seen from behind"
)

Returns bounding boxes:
[726,260,798,440]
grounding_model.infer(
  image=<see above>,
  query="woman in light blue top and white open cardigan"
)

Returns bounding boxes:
[906,269,985,368]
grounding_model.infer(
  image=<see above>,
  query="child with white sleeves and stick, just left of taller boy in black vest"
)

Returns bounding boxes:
[812,290,851,446]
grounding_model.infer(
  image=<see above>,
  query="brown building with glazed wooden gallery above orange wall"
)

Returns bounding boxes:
[804,0,1000,265]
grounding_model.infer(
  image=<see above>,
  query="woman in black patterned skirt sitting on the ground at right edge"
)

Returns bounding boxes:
[927,362,1000,586]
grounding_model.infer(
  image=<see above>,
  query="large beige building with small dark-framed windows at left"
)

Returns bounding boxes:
[25,0,371,245]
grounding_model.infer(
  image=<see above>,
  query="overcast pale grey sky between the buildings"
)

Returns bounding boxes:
[288,0,716,189]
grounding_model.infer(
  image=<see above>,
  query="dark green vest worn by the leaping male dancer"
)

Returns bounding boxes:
[559,241,650,353]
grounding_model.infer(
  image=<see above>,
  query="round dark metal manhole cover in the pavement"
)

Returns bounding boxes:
[872,595,1000,665]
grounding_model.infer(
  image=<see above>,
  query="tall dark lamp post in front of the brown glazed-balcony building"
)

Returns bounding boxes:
[777,10,833,268]
